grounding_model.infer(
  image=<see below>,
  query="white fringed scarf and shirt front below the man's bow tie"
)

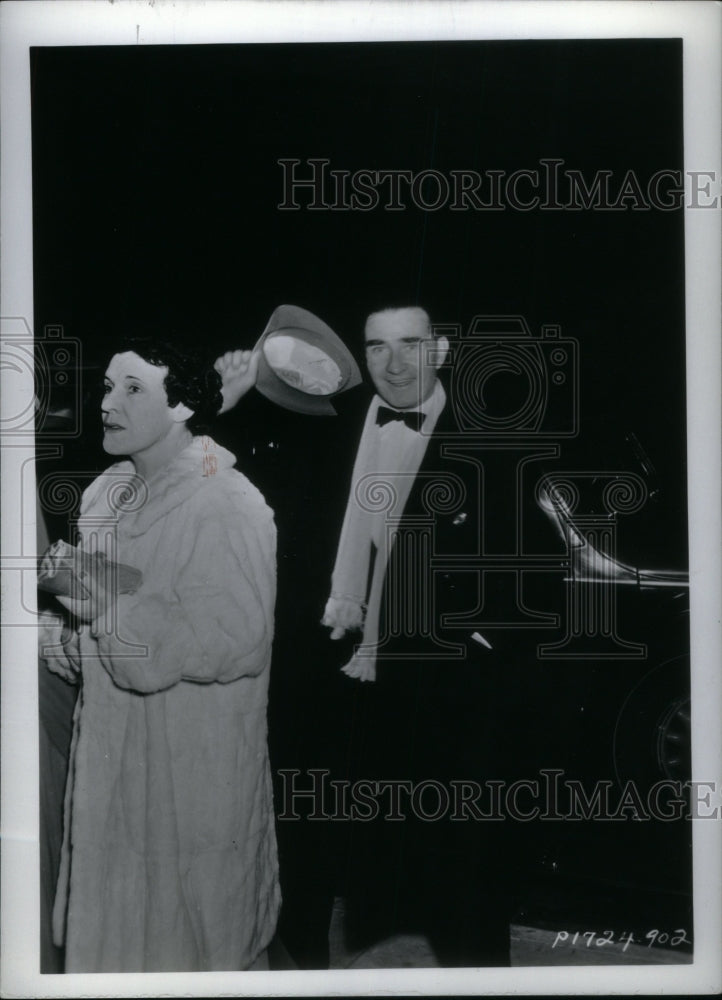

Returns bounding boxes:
[322,380,446,681]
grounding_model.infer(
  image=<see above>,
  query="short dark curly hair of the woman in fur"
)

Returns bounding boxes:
[107,337,223,434]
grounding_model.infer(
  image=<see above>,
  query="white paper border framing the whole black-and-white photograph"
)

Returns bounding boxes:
[0,0,722,997]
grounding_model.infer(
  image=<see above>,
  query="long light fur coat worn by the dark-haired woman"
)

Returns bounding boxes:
[54,438,280,972]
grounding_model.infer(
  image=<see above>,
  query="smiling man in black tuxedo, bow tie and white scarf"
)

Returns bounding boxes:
[323,307,510,966]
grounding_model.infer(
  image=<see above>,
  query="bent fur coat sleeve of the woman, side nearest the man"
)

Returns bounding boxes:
[93,486,276,694]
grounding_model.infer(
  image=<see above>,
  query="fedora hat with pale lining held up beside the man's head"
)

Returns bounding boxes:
[254,305,361,416]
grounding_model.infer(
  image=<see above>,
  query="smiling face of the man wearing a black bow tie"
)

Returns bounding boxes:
[366,309,437,410]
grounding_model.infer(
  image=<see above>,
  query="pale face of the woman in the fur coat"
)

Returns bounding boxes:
[101,351,179,457]
